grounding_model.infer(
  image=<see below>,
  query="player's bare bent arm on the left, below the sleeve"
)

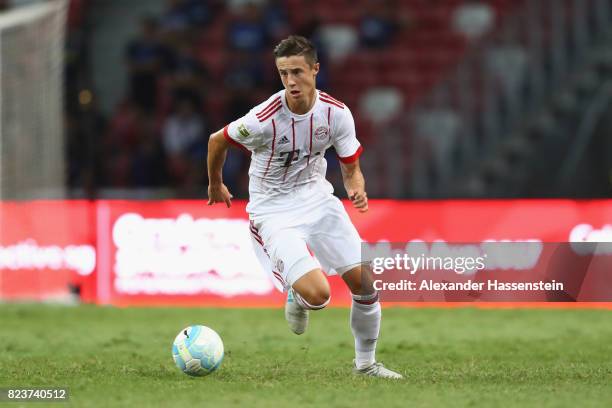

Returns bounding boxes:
[207,129,234,208]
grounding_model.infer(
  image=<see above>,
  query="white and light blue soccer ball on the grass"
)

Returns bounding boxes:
[172,325,223,377]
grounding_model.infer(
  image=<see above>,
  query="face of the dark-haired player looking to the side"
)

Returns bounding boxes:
[276,55,319,103]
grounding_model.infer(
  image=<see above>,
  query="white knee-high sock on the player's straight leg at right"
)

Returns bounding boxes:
[351,293,381,369]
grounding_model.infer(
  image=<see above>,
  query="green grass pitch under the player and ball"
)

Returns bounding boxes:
[0,305,612,408]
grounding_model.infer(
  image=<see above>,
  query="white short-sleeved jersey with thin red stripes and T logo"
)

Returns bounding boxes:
[223,90,362,216]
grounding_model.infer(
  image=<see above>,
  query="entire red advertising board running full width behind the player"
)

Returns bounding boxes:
[0,200,612,307]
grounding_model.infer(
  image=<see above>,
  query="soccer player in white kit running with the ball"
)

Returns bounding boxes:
[208,36,402,379]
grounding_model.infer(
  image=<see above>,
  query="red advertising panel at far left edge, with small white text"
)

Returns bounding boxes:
[0,201,96,301]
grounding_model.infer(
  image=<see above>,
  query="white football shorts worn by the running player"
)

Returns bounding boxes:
[250,194,361,291]
